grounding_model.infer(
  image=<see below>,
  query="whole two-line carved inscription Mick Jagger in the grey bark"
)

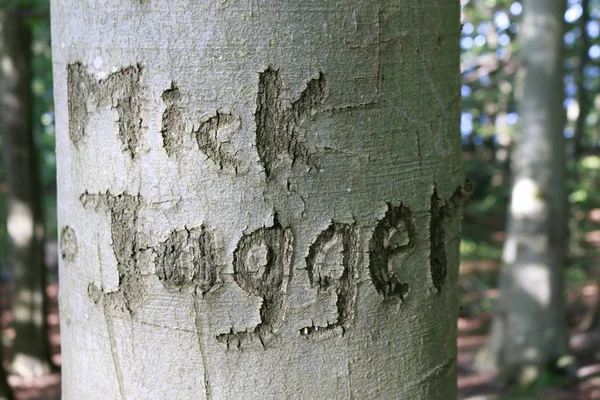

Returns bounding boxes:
[65,63,464,349]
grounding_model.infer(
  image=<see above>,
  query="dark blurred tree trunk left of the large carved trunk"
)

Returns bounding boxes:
[2,8,50,376]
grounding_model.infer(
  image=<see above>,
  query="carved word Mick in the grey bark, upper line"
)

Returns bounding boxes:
[67,63,326,178]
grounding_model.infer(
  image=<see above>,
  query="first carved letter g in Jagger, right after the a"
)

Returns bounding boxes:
[217,219,293,348]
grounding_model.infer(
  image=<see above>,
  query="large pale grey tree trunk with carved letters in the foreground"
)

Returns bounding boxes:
[52,0,464,399]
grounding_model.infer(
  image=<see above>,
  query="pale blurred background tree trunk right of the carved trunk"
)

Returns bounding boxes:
[481,0,567,383]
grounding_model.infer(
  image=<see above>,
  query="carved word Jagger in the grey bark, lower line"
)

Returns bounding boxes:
[71,187,464,349]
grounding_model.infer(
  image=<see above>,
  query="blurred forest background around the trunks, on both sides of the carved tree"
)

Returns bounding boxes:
[0,0,600,399]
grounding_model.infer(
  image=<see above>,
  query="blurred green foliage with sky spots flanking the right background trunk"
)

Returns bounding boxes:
[460,0,600,283]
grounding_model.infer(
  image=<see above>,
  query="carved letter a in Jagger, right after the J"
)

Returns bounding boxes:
[155,226,217,294]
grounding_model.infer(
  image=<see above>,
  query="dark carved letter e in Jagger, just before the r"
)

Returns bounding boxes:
[369,205,417,301]
